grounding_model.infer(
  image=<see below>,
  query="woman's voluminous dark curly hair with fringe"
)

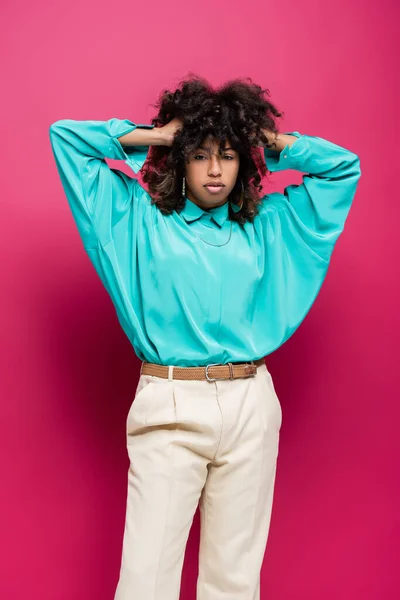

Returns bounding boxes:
[143,74,284,224]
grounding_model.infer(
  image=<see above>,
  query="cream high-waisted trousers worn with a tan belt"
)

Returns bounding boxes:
[114,363,282,600]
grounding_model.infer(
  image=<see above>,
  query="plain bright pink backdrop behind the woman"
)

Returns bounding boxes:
[0,0,400,600]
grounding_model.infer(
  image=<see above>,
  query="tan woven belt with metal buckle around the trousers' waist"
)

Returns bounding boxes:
[140,358,265,381]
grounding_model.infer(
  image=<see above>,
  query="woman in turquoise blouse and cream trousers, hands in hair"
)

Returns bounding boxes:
[50,77,361,600]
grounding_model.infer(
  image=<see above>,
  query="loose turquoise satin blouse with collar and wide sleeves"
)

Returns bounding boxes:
[50,118,361,366]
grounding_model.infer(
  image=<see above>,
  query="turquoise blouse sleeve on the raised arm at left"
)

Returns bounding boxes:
[49,118,154,249]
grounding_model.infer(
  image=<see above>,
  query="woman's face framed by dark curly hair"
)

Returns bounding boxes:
[185,138,240,209]
